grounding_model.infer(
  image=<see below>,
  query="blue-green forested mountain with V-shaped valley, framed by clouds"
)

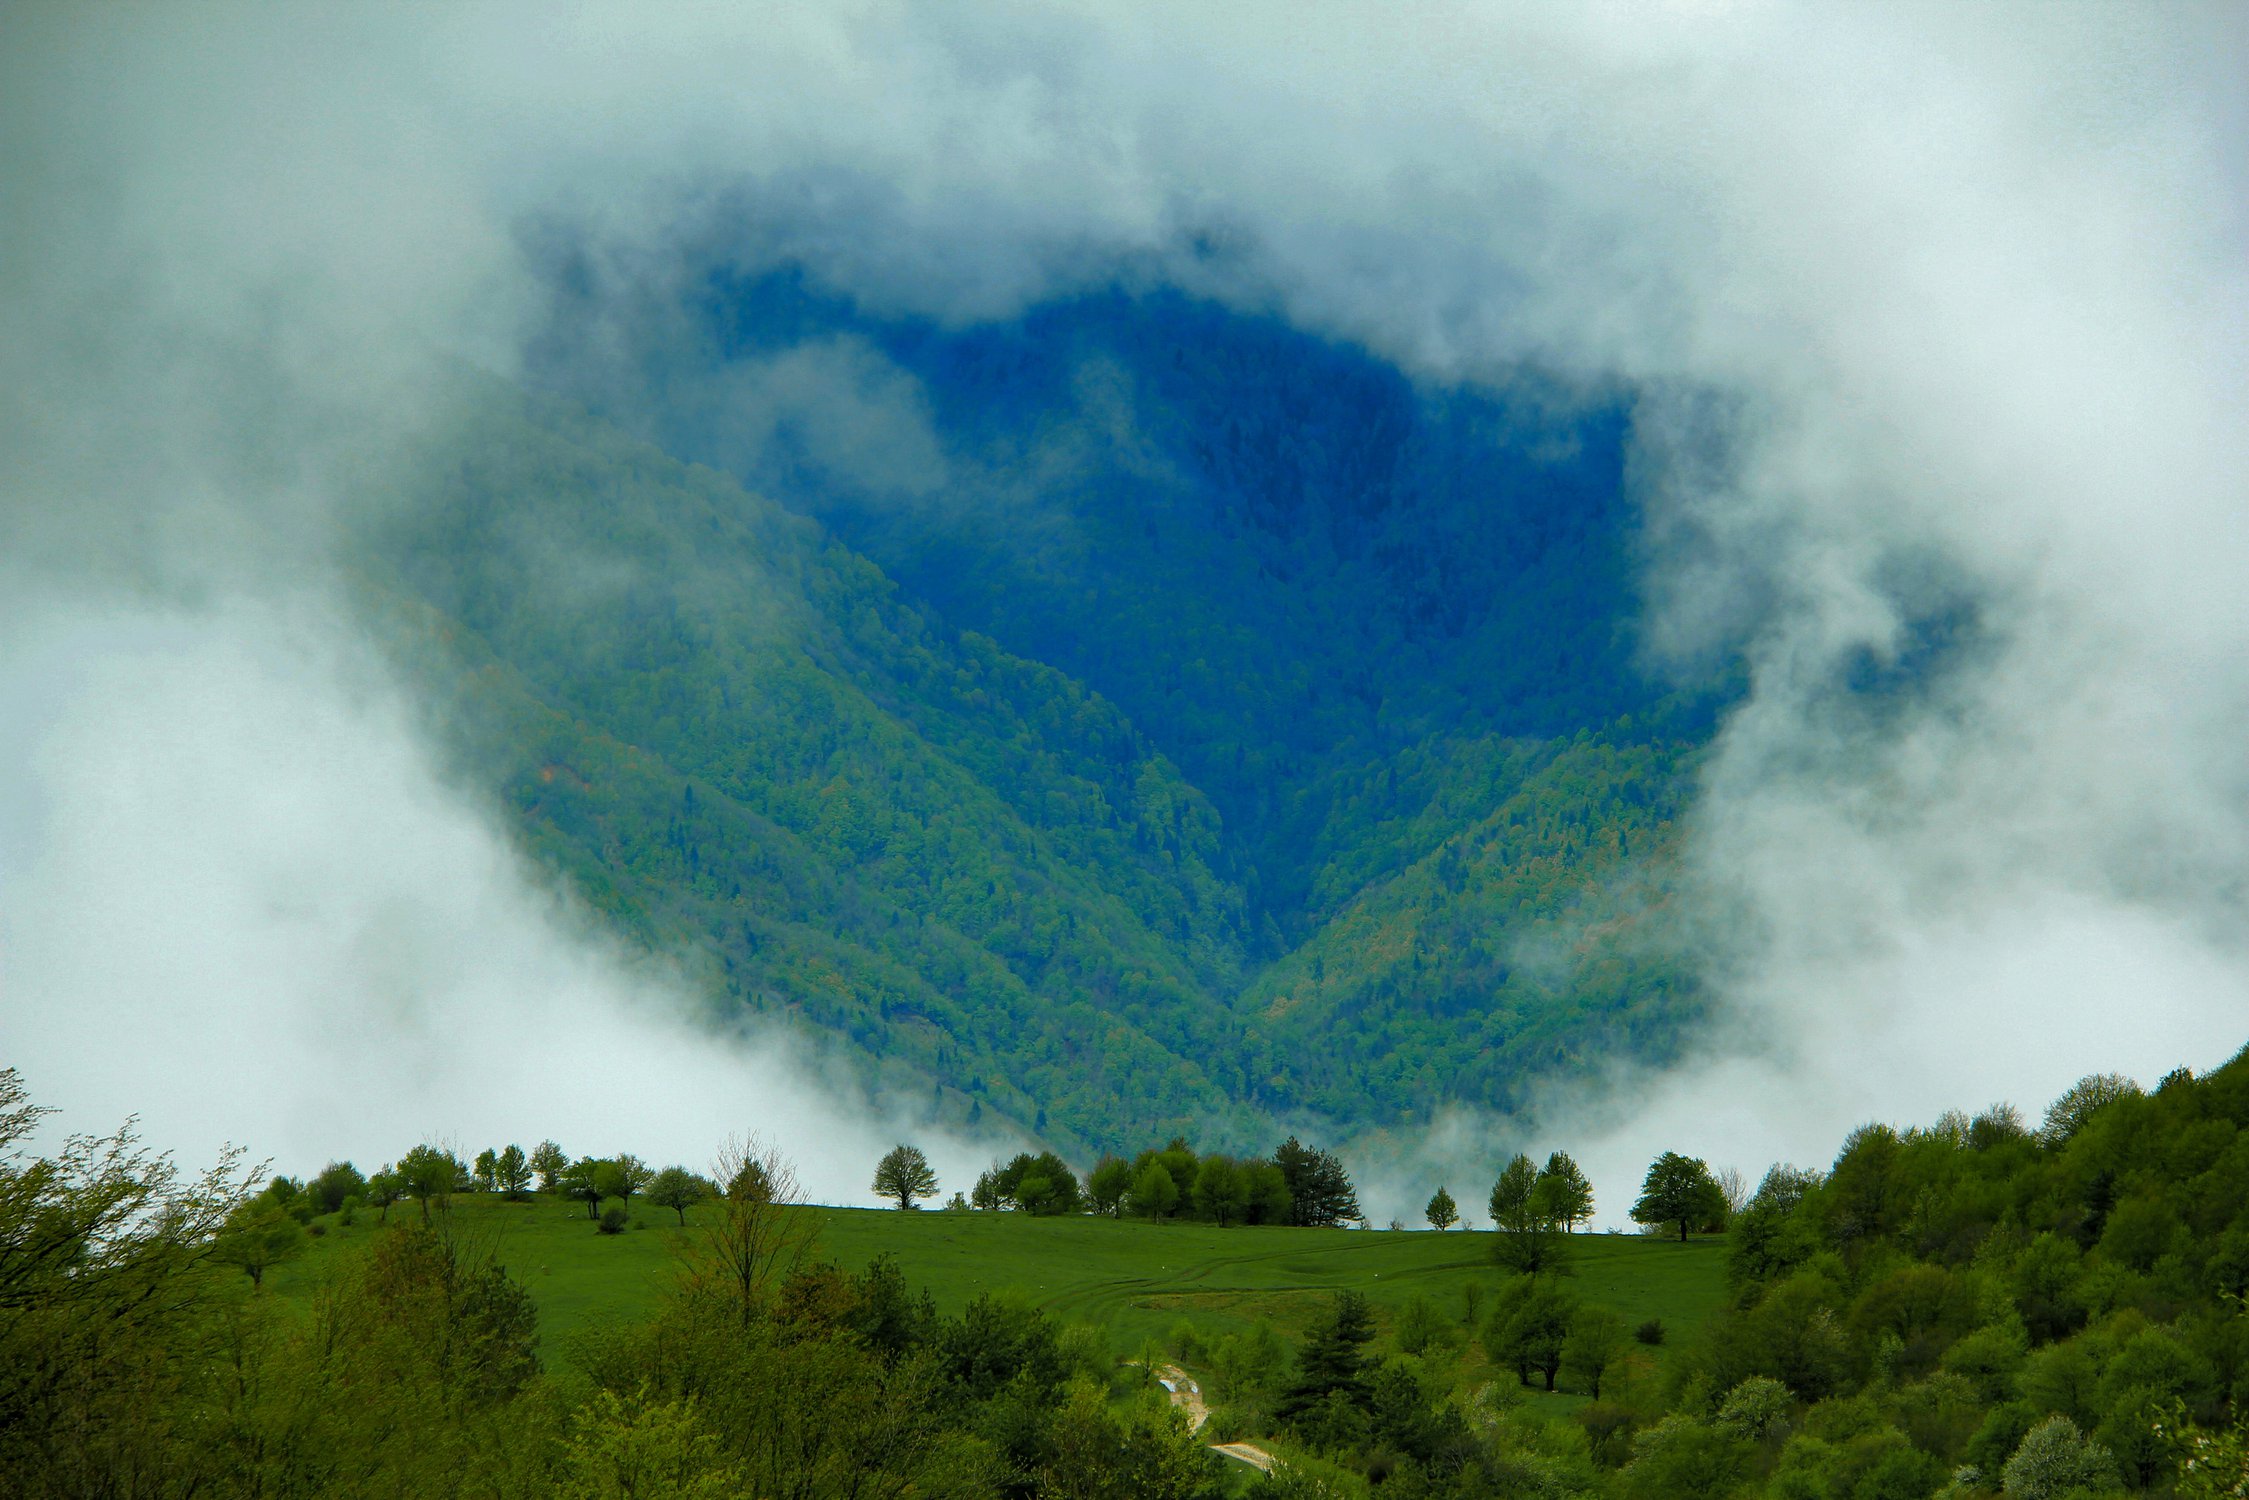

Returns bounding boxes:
[360,277,1723,1149]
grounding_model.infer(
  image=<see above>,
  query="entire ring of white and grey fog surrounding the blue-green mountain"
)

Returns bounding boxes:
[0,4,2249,1221]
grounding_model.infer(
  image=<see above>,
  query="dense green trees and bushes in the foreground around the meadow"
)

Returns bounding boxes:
[0,1055,2249,1500]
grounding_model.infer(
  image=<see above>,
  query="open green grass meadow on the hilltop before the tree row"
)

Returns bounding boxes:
[270,1196,1725,1412]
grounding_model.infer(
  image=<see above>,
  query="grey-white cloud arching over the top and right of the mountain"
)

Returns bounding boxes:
[0,2,2249,1196]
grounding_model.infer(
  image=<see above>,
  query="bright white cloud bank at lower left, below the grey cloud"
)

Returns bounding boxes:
[0,598,1003,1203]
